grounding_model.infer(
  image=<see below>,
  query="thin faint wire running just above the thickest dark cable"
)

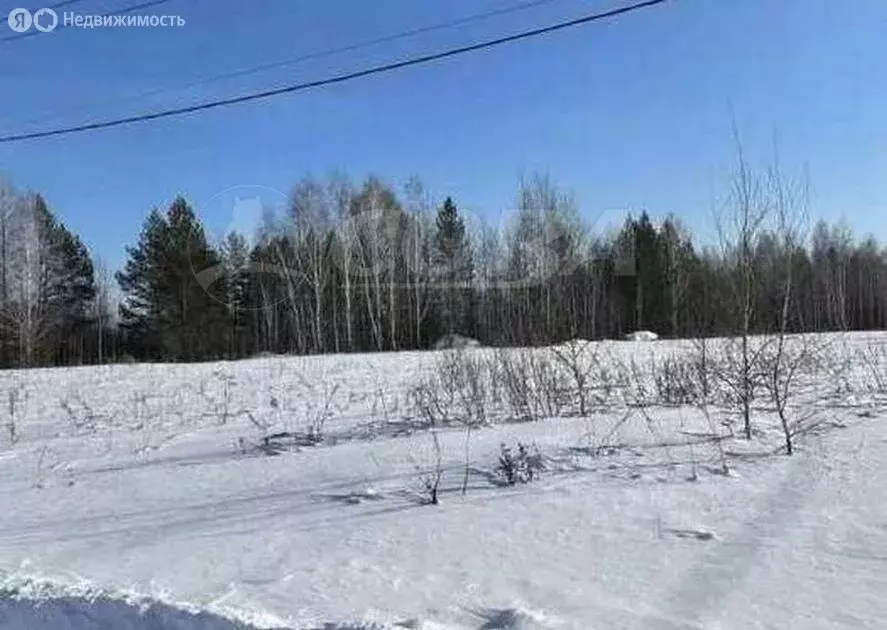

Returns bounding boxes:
[4,0,559,132]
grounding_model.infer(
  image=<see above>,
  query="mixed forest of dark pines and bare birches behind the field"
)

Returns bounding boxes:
[0,171,887,367]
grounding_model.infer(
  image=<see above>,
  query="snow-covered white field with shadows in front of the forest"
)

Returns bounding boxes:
[0,333,887,630]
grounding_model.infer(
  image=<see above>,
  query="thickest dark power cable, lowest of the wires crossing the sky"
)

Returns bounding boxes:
[0,0,668,144]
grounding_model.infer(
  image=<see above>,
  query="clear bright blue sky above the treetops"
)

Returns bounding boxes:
[0,0,887,266]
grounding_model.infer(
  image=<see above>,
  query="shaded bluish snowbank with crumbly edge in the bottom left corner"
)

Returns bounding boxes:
[0,579,283,630]
